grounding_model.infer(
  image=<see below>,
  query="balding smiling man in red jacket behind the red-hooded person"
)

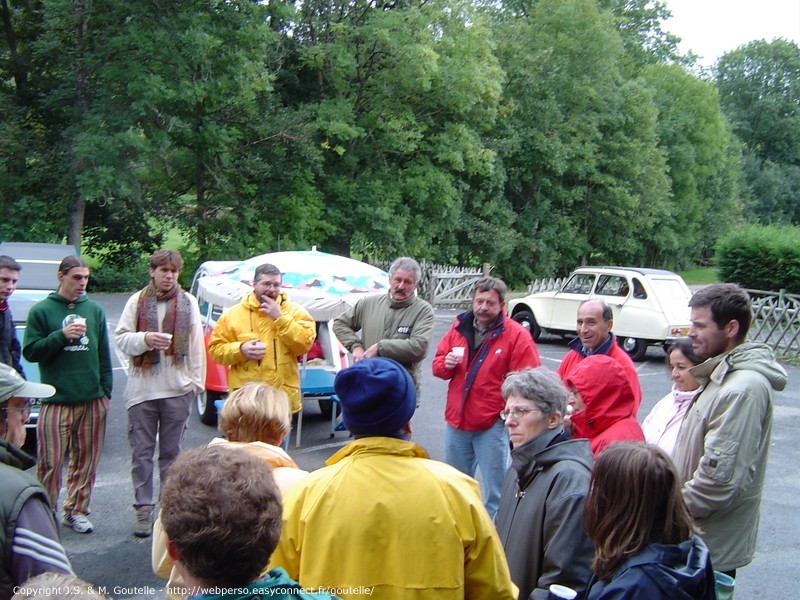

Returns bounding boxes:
[556,300,642,417]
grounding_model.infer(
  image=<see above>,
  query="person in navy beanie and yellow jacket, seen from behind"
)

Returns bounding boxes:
[270,357,517,600]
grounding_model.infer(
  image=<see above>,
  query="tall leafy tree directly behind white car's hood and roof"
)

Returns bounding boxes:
[498,0,669,278]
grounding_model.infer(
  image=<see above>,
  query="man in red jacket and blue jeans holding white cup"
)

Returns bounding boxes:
[433,277,542,518]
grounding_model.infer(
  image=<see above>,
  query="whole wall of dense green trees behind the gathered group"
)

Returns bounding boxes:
[0,0,800,283]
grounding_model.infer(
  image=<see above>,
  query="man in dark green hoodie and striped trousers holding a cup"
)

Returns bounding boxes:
[22,255,113,533]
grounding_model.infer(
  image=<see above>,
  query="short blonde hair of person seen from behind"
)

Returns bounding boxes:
[219,382,292,446]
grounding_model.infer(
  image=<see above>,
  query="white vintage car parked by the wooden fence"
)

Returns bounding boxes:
[508,267,692,361]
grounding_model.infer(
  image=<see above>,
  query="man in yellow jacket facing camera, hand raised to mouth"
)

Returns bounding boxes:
[208,263,317,413]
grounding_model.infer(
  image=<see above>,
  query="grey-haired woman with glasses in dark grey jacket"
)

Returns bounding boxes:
[495,367,594,600]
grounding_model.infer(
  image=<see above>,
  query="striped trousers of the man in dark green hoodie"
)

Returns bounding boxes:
[36,397,108,515]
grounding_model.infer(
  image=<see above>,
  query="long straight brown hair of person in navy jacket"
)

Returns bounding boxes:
[585,442,695,580]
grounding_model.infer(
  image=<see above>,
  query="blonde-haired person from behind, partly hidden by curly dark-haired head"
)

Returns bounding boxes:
[152,382,308,599]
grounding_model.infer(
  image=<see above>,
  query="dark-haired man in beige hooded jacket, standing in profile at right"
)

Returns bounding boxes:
[673,283,786,576]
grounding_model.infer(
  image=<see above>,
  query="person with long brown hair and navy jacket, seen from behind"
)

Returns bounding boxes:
[585,442,717,600]
